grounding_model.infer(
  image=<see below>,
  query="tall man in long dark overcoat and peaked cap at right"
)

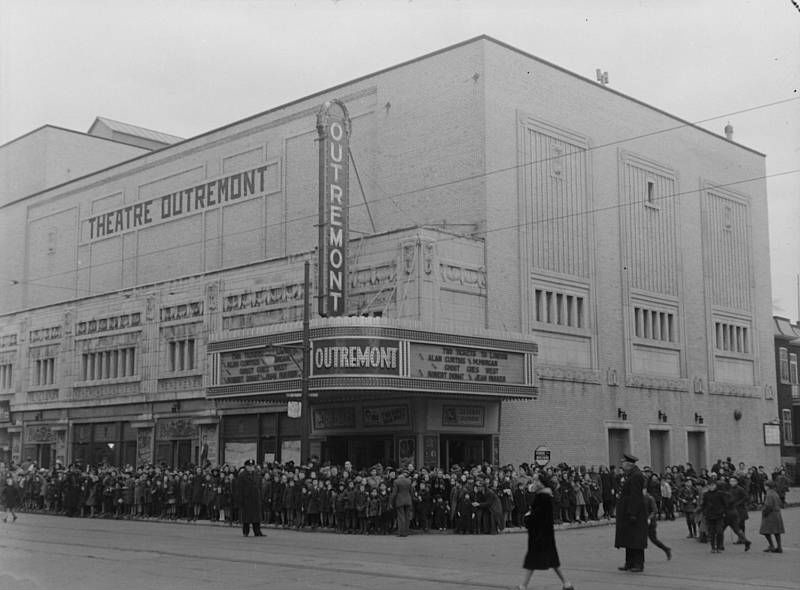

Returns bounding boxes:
[614,453,647,572]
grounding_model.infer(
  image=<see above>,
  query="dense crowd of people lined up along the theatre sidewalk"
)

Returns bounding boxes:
[0,459,789,548]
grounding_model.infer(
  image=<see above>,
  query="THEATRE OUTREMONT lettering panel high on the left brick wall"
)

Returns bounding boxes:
[84,164,272,240]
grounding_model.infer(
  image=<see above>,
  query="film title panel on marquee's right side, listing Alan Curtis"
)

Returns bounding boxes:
[411,343,525,384]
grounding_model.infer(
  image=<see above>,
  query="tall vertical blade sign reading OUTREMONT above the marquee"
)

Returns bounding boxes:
[317,100,350,317]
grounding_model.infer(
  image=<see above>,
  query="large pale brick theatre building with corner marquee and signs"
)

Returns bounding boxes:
[0,37,779,468]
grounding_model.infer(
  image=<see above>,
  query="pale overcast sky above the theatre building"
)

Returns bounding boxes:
[0,0,800,321]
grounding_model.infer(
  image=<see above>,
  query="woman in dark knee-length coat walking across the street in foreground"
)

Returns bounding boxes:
[517,475,574,590]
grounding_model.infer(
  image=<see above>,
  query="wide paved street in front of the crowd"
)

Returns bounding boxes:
[0,508,800,590]
